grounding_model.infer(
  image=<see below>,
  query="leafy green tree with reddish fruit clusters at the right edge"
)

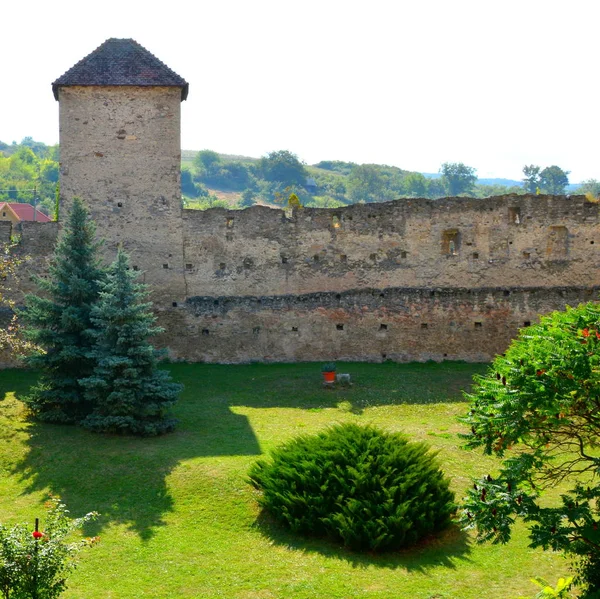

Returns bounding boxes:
[461,303,600,597]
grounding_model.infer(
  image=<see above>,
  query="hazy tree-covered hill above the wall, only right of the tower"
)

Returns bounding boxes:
[182,150,600,208]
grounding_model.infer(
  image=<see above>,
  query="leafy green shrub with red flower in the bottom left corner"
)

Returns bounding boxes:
[0,498,97,599]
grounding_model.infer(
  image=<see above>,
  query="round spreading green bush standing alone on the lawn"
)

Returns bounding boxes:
[249,424,456,551]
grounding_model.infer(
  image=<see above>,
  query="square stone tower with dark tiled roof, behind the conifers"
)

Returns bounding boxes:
[52,38,188,310]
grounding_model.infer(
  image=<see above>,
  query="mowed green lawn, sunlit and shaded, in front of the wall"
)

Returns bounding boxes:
[0,363,568,599]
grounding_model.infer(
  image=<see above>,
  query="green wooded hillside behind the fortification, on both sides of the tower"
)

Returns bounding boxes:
[0,137,600,218]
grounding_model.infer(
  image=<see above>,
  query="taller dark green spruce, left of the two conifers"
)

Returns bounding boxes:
[22,198,104,423]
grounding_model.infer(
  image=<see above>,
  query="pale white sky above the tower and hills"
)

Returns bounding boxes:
[0,0,600,183]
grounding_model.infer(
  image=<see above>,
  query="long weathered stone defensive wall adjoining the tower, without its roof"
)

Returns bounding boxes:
[0,195,600,362]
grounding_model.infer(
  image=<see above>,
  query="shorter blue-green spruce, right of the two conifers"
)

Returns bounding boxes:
[80,250,182,435]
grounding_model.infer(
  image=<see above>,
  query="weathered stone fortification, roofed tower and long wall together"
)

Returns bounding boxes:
[0,39,600,362]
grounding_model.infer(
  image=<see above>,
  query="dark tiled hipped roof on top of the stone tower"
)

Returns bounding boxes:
[52,38,188,100]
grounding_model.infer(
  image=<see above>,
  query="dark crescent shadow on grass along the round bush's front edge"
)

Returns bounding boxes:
[254,510,471,572]
